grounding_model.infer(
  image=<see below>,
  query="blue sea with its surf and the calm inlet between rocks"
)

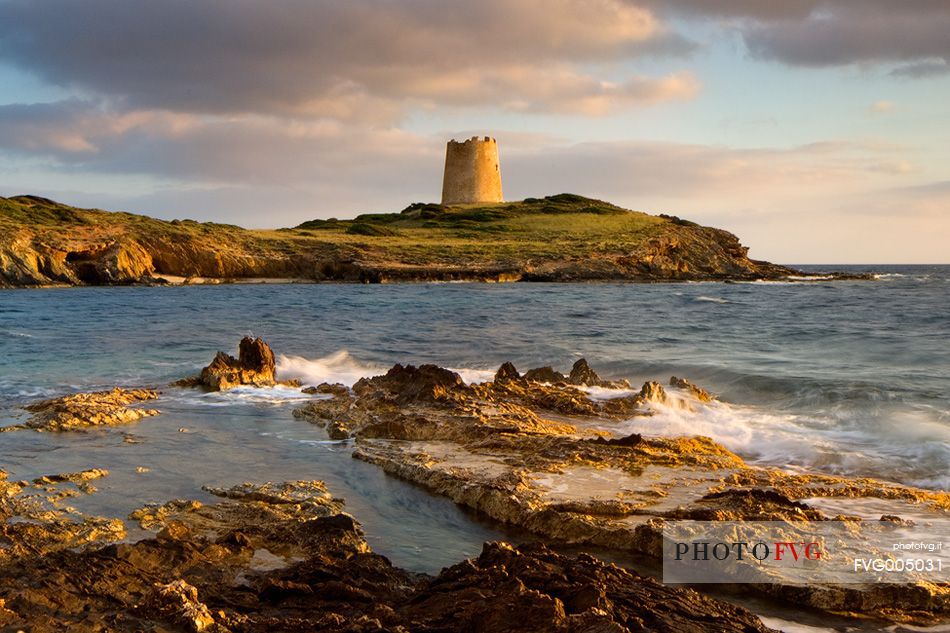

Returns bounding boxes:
[0,266,950,571]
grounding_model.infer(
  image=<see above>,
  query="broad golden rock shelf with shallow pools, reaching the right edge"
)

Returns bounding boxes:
[295,361,950,624]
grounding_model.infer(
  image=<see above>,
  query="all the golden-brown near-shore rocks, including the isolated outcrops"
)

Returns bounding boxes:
[0,338,950,633]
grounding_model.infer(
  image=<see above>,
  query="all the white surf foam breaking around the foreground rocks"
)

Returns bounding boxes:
[193,350,950,489]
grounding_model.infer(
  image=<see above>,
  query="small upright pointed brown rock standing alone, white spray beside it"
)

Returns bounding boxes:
[177,336,277,391]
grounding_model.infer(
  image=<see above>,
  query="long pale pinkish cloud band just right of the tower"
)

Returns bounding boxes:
[505,141,924,202]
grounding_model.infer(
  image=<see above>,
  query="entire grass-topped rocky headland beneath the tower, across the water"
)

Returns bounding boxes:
[0,194,832,287]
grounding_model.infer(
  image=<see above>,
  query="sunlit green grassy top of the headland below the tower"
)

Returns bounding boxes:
[0,194,685,265]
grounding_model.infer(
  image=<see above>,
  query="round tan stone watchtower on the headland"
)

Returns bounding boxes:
[442,136,504,204]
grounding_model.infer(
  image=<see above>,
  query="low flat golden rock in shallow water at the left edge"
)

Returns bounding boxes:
[0,387,159,432]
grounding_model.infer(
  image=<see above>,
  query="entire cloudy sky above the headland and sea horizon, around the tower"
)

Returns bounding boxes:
[0,0,950,264]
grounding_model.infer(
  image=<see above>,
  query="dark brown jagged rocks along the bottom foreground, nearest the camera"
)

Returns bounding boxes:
[0,481,770,633]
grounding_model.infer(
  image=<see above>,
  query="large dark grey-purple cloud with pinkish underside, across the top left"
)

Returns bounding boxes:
[0,0,697,118]
